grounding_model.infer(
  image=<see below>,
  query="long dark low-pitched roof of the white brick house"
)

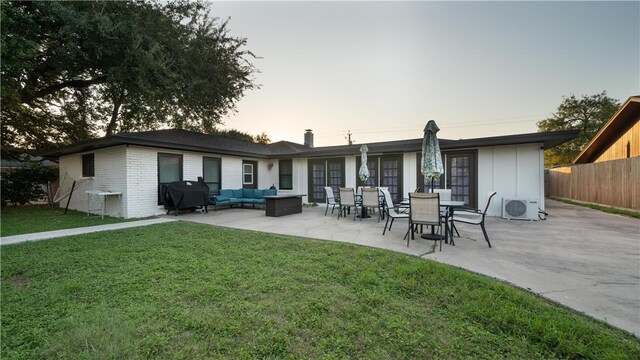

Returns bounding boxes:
[42,129,578,158]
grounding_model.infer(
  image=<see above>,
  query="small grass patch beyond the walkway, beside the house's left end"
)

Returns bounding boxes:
[0,206,139,236]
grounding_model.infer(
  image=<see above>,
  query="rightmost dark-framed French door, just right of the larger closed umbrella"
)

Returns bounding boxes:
[446,151,478,207]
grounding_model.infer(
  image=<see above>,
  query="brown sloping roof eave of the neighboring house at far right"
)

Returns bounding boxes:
[573,96,640,164]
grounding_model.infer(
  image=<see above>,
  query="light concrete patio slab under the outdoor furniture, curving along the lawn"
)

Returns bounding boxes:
[178,200,640,336]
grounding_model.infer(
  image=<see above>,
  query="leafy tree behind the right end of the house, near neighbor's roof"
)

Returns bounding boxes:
[537,91,620,168]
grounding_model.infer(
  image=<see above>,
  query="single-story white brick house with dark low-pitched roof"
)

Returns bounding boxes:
[43,129,577,218]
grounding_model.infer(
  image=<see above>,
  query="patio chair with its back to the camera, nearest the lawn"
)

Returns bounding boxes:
[407,193,445,251]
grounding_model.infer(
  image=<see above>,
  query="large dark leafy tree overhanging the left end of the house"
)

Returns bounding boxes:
[0,0,257,150]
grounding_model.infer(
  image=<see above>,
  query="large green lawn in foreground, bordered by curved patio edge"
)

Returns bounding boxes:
[0,222,640,359]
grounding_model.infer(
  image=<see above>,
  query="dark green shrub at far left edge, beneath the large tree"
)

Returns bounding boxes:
[0,161,58,206]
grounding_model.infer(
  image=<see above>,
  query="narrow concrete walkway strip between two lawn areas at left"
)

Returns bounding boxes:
[0,218,176,245]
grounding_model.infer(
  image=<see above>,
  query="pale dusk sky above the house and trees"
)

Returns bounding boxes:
[211,1,640,146]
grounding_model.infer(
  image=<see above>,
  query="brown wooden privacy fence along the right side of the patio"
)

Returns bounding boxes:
[545,157,640,210]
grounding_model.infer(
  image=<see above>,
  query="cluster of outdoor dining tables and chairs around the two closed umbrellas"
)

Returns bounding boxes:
[324,187,496,251]
